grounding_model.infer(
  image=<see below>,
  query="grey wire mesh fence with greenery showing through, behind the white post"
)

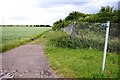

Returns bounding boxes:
[62,22,120,53]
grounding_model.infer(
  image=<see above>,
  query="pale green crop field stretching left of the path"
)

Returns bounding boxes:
[0,27,51,52]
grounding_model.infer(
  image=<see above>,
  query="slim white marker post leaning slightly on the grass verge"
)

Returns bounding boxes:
[102,21,110,72]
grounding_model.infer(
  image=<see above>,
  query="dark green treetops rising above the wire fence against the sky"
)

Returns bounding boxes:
[52,6,120,30]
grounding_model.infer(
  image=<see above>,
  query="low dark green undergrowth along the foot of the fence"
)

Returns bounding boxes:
[50,35,120,53]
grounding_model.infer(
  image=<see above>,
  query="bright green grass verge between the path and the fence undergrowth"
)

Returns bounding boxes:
[34,31,120,78]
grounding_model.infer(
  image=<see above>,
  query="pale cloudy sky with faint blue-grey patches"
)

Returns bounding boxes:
[0,0,120,25]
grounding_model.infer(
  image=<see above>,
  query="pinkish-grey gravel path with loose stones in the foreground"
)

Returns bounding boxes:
[2,44,57,78]
